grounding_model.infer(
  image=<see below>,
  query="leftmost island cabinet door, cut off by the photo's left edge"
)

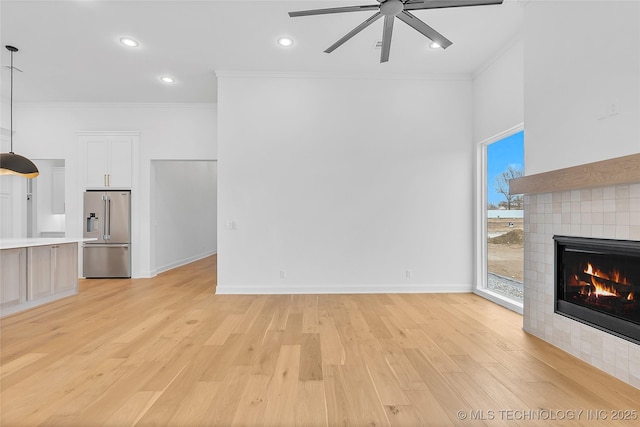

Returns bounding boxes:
[0,248,27,306]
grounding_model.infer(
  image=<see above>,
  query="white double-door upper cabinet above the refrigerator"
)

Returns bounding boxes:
[80,133,137,189]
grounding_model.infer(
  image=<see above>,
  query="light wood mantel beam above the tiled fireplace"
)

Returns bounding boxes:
[509,154,640,194]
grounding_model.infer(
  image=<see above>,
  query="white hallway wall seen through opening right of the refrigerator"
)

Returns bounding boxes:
[151,160,217,273]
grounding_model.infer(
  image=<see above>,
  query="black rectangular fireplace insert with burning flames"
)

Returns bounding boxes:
[553,236,640,343]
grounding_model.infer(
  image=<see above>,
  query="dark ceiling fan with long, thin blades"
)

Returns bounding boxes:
[289,0,503,63]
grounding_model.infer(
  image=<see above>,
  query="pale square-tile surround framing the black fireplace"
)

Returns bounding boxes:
[523,182,640,388]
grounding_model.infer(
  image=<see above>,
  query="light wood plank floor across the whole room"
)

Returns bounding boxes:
[0,257,640,426]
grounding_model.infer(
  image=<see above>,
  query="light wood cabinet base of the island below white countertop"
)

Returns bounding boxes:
[0,243,78,316]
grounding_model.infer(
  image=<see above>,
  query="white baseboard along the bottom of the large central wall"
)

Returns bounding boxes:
[216,283,473,295]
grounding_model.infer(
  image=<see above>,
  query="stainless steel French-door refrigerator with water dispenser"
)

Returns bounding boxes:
[82,191,131,278]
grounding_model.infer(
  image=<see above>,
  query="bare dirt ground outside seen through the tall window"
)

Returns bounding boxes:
[487,218,524,282]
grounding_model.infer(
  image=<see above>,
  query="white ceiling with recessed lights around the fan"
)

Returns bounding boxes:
[0,0,522,102]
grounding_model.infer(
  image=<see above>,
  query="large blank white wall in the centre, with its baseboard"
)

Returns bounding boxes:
[217,73,474,293]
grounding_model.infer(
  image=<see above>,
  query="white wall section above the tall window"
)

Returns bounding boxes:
[473,36,526,143]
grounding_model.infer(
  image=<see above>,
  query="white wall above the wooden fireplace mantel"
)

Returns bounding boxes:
[524,0,640,175]
